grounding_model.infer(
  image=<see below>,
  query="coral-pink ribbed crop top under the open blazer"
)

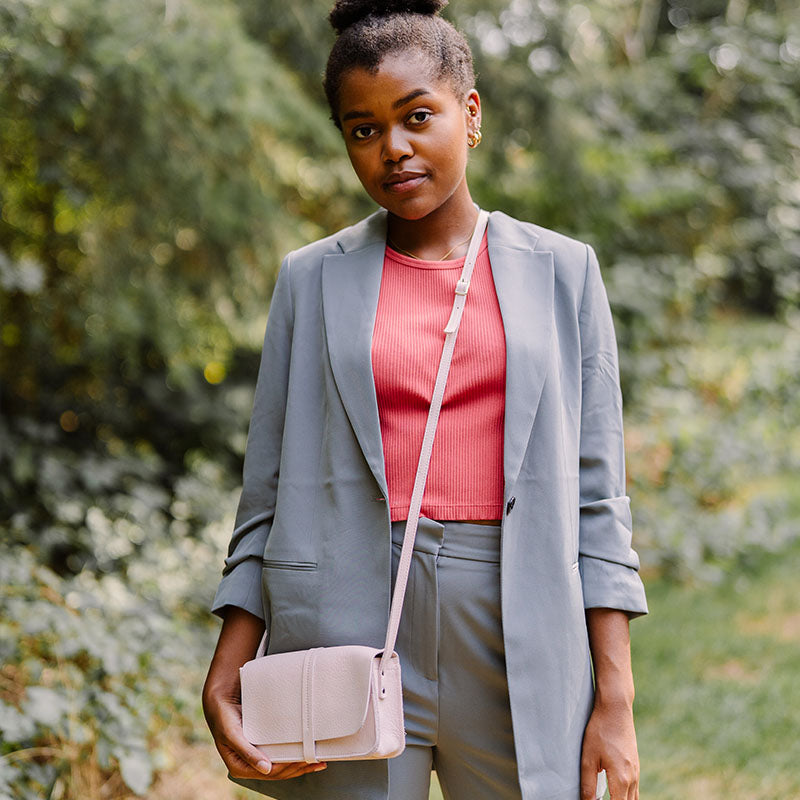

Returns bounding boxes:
[372,234,506,521]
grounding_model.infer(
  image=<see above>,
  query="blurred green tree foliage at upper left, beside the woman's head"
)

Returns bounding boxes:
[0,0,355,456]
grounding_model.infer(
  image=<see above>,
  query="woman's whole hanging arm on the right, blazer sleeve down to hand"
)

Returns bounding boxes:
[579,248,647,800]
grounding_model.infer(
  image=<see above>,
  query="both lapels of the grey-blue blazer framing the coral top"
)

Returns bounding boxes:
[322,209,554,502]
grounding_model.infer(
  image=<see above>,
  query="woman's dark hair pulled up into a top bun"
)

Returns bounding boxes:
[323,0,475,129]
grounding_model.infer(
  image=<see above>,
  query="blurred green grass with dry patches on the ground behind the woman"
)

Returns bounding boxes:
[149,546,800,800]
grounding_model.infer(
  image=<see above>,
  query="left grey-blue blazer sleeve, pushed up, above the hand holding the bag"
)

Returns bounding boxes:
[211,256,294,625]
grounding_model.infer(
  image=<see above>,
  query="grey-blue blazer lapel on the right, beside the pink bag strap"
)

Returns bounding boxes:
[488,211,554,499]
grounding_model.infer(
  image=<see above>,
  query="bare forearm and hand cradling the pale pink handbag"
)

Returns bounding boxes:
[203,607,327,780]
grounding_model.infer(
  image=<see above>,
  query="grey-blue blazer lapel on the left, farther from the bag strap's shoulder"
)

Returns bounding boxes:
[322,209,388,497]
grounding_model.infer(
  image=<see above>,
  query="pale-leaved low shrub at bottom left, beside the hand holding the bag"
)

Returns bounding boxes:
[0,544,219,800]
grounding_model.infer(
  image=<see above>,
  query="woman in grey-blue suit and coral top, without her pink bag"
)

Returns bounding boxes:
[204,0,647,800]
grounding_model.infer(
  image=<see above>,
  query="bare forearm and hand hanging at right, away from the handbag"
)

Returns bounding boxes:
[581,608,639,800]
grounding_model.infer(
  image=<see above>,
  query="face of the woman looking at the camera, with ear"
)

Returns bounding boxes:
[339,51,480,220]
